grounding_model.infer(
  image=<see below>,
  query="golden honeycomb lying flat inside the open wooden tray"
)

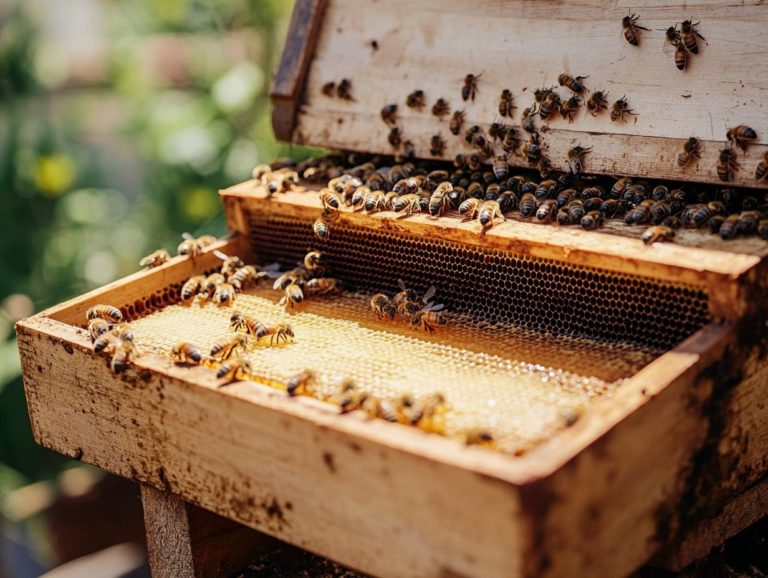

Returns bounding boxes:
[130,288,636,453]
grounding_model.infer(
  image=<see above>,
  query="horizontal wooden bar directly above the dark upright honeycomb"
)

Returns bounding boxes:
[222,181,768,319]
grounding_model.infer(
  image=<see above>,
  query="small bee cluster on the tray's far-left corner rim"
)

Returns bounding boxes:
[85,305,138,373]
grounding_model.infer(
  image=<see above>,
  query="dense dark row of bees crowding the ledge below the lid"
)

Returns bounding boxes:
[296,151,768,243]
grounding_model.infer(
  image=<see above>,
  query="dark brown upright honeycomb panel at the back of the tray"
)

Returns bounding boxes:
[249,213,709,346]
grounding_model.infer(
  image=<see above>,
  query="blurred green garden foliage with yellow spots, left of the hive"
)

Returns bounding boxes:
[0,0,308,486]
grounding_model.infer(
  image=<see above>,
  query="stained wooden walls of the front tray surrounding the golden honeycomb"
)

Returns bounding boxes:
[18,226,768,576]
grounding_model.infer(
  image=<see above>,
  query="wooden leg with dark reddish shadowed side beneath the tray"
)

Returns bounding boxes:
[141,486,279,578]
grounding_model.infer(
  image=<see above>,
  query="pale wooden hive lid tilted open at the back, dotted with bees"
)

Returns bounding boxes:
[272,0,768,188]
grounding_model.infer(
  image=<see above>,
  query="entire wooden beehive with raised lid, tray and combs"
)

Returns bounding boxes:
[12,0,768,577]
